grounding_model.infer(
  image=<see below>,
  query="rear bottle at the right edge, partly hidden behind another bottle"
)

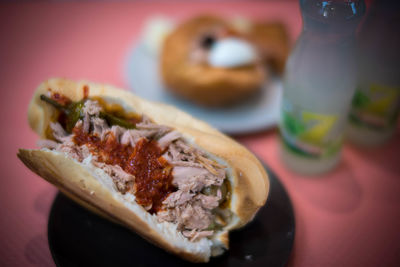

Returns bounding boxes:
[346,0,400,146]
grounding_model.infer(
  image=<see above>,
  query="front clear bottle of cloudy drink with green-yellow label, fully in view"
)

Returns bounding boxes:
[280,0,365,174]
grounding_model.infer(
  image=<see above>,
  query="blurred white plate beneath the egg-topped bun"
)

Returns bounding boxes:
[125,44,282,134]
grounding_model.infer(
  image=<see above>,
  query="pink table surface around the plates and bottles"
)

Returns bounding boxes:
[0,1,400,266]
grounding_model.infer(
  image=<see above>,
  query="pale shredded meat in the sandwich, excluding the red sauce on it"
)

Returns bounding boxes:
[42,100,226,241]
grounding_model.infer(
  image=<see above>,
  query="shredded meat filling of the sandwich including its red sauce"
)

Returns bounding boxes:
[39,99,227,241]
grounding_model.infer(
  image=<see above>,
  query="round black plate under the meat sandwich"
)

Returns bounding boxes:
[48,166,295,267]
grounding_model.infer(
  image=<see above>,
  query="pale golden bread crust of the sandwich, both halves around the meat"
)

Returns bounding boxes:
[18,79,269,262]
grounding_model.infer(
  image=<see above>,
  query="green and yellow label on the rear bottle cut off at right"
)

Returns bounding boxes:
[349,84,400,131]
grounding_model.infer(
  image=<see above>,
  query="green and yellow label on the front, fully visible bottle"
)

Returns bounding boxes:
[281,100,343,158]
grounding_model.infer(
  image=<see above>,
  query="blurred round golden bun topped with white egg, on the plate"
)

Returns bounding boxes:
[161,16,266,106]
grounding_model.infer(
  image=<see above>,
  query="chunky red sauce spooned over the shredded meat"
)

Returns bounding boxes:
[73,127,176,214]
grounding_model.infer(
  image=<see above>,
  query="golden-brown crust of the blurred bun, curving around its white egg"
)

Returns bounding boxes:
[160,16,267,106]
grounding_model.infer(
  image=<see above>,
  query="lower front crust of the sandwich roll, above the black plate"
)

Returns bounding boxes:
[18,149,210,262]
